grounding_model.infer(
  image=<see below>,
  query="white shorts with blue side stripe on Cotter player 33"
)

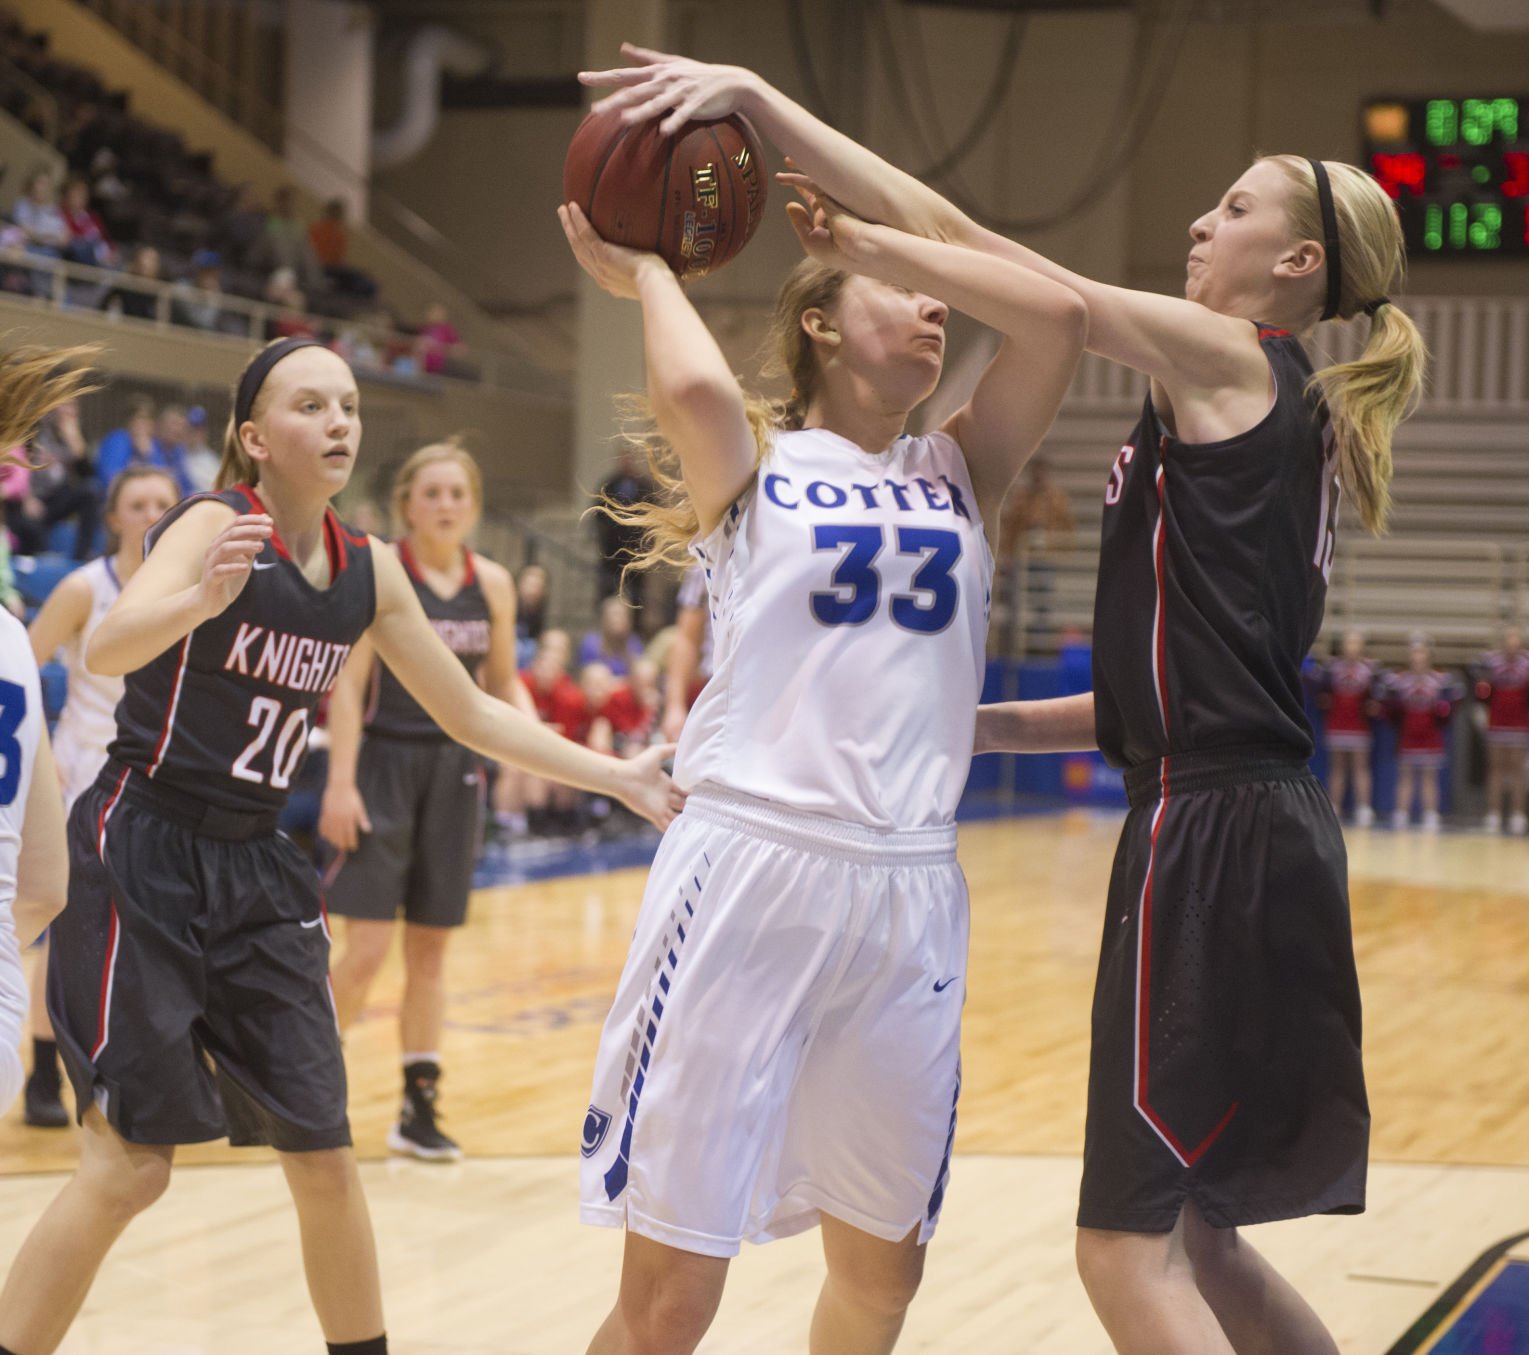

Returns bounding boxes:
[581,785,968,1256]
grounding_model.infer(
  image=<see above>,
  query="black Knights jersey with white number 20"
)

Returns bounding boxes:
[110,485,376,814]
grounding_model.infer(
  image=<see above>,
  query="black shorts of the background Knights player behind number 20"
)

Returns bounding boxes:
[324,736,483,927]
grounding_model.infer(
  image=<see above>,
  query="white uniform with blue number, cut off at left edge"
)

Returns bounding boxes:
[0,610,43,1112]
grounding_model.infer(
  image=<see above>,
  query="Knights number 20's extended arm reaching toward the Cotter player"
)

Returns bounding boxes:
[367,541,683,827]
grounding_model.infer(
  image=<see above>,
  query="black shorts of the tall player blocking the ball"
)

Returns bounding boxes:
[1078,749,1370,1233]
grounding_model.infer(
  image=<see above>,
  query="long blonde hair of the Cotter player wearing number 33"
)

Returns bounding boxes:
[595,258,850,574]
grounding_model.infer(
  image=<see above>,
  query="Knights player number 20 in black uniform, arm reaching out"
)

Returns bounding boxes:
[0,340,673,1355]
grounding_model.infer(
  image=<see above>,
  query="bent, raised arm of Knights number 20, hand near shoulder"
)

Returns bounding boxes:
[84,500,272,678]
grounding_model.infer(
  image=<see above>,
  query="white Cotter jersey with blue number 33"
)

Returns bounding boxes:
[674,428,992,827]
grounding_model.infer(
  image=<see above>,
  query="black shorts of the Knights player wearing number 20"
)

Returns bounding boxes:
[47,762,350,1152]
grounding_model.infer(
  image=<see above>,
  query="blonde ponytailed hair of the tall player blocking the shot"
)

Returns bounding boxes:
[1261,156,1428,535]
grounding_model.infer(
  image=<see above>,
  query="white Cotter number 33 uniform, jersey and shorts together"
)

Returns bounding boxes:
[583,428,992,1256]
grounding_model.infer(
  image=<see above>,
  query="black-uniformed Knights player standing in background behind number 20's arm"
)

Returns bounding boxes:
[320,442,535,1161]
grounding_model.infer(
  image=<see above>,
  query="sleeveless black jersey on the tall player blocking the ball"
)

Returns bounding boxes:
[1093,326,1338,766]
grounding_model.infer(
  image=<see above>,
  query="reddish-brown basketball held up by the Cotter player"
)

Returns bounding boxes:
[563,112,768,281]
